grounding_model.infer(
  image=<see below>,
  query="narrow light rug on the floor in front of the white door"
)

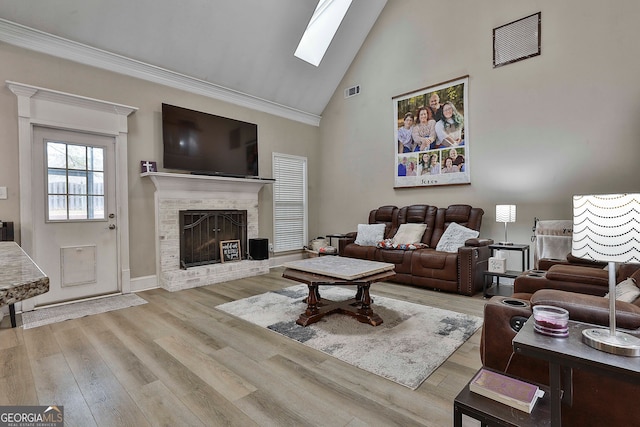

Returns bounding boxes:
[22,294,147,329]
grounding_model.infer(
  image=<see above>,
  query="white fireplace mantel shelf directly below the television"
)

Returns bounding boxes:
[140,172,275,194]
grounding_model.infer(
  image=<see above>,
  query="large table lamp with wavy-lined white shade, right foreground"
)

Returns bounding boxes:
[571,194,640,356]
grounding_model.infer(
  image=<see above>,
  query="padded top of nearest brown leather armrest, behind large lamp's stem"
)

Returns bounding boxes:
[531,289,640,332]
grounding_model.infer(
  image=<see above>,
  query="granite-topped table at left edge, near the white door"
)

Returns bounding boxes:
[0,242,49,328]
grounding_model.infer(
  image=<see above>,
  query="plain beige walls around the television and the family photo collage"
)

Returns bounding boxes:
[0,0,640,278]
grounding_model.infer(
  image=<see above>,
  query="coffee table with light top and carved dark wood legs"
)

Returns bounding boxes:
[282,256,396,326]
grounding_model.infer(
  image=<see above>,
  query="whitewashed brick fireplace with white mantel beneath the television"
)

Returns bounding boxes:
[141,172,273,291]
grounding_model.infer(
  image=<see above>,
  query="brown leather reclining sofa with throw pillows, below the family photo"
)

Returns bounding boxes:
[338,205,493,295]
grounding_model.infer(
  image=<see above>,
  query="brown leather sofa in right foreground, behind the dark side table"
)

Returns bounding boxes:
[480,265,640,426]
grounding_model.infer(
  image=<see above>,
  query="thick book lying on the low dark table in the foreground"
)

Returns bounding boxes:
[469,369,544,414]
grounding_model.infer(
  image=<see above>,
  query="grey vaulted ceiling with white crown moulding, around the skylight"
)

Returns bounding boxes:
[0,0,386,123]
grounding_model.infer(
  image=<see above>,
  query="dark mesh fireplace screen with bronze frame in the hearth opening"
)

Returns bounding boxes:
[180,210,247,269]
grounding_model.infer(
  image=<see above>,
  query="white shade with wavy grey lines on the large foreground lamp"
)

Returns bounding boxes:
[571,194,640,263]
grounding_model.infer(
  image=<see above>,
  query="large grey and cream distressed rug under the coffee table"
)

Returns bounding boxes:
[216,285,482,390]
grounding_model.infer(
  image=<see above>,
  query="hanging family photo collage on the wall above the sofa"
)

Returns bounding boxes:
[392,76,471,188]
